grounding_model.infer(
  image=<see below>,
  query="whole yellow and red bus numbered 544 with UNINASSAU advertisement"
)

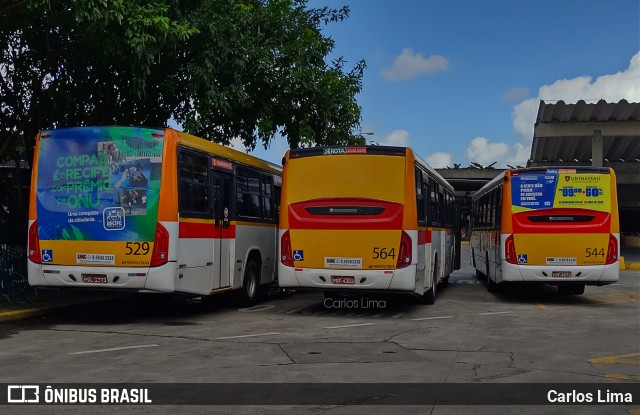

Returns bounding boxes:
[471,167,620,294]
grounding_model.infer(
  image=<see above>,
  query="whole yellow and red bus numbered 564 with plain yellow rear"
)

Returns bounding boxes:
[278,146,457,304]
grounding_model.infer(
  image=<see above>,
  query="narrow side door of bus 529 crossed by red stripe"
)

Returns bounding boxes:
[211,171,235,290]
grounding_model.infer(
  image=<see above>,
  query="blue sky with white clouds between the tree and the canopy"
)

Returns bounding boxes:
[236,0,640,168]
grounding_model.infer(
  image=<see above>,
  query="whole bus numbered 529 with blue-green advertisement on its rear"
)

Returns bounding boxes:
[28,127,282,303]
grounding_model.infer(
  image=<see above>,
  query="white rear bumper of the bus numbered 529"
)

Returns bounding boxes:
[27,260,176,293]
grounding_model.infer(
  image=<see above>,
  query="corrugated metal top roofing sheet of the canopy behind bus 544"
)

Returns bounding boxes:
[536,99,640,124]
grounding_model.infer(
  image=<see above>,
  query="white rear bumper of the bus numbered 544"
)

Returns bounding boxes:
[499,261,620,285]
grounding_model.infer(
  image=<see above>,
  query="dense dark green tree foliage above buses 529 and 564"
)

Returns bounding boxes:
[0,0,365,161]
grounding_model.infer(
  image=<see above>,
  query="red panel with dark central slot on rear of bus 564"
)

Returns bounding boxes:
[288,198,404,230]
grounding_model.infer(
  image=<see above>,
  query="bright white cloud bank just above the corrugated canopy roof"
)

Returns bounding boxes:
[512,52,640,142]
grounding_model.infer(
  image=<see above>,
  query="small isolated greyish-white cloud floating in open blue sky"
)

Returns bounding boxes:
[380,48,449,82]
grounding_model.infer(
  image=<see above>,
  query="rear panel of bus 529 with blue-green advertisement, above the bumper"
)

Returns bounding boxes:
[36,127,164,266]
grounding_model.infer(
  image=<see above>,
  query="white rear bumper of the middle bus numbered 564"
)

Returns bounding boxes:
[278,264,416,293]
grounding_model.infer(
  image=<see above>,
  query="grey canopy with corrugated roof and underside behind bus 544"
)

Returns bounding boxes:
[530,100,640,163]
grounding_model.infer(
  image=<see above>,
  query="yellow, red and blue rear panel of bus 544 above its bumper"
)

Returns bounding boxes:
[511,169,612,268]
